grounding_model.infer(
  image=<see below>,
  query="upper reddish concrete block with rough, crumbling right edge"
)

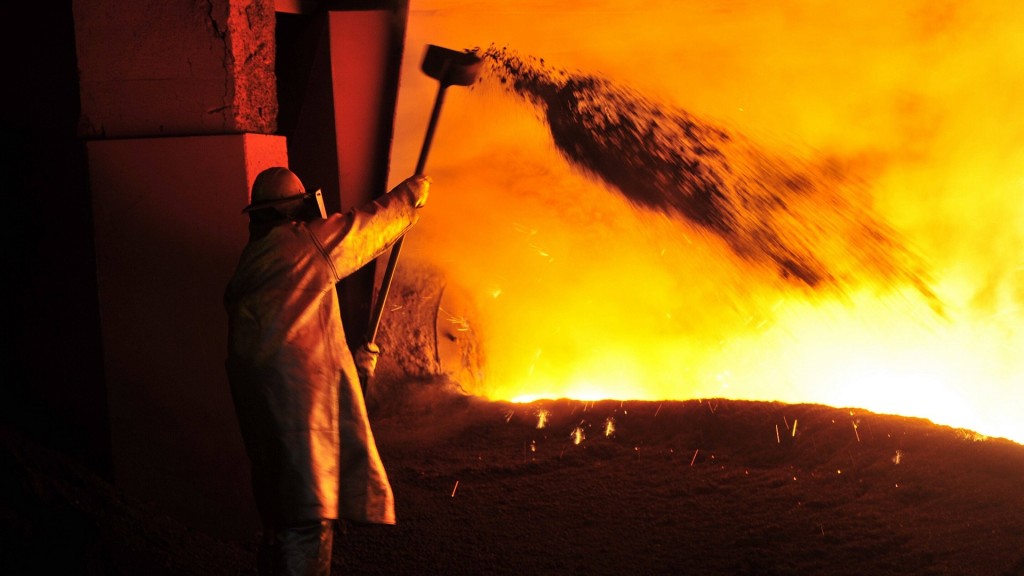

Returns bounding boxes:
[74,0,278,138]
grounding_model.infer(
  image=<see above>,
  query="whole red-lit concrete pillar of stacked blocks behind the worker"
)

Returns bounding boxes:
[74,0,288,539]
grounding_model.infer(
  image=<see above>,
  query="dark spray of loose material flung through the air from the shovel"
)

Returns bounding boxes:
[476,46,940,311]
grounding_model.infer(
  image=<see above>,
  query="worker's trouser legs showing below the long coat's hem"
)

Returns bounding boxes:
[259,520,334,576]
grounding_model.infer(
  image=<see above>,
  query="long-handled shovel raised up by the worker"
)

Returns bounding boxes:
[364,44,481,388]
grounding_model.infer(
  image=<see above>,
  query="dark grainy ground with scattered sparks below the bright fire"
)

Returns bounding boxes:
[0,387,1024,575]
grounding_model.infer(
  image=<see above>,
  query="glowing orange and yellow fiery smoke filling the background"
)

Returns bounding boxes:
[392,0,1024,444]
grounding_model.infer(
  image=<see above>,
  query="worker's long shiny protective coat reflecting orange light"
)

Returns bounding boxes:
[224,181,417,526]
